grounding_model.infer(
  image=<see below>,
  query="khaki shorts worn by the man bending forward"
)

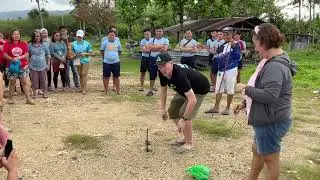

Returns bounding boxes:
[168,93,206,119]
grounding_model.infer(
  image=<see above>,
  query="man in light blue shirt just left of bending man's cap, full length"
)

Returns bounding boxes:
[139,29,152,91]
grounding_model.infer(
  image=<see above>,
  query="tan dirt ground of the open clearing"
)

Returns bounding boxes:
[0,59,320,180]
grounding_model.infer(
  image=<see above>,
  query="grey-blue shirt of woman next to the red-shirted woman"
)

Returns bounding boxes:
[28,43,50,71]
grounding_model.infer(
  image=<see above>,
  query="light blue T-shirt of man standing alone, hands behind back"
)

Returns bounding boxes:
[100,40,122,64]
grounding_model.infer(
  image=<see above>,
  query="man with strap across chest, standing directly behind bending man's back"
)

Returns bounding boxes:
[180,30,198,68]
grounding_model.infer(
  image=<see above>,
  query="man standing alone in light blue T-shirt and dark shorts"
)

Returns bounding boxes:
[100,31,122,95]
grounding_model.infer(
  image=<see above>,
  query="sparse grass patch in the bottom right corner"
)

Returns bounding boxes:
[282,165,320,180]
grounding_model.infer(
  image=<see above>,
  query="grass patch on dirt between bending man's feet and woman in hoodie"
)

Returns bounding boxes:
[192,120,241,138]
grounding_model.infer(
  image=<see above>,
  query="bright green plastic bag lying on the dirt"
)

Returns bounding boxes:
[186,165,211,180]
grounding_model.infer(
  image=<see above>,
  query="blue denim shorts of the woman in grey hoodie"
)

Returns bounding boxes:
[253,119,292,156]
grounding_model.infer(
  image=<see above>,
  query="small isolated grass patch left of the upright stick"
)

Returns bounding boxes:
[64,134,100,150]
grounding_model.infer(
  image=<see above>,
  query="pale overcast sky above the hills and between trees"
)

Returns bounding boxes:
[0,0,320,18]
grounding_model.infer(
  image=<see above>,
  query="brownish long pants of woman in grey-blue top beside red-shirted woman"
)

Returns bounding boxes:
[30,70,48,92]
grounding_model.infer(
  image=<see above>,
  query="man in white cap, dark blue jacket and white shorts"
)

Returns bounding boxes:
[205,27,241,115]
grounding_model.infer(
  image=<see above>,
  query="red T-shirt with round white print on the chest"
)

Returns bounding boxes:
[3,41,29,69]
